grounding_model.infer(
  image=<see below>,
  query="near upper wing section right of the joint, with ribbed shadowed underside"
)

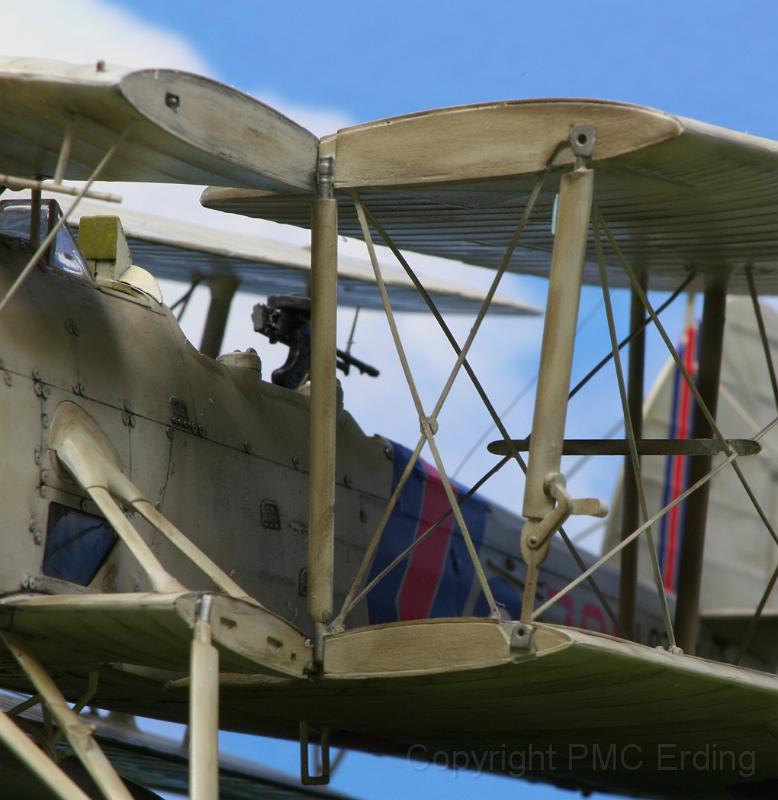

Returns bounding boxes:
[202,100,778,293]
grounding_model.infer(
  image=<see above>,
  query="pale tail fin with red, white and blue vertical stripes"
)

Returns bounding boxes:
[603,298,778,621]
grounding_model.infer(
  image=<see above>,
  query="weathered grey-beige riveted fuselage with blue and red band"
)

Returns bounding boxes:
[0,211,662,664]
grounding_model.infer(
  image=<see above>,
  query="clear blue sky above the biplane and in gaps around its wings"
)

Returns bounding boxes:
[98,0,778,800]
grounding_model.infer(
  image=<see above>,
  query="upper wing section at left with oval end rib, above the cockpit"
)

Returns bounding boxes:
[0,59,319,191]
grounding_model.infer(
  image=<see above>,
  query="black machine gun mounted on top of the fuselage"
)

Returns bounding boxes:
[251,294,379,389]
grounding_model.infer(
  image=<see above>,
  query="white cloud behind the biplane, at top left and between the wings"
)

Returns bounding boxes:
[0,0,632,552]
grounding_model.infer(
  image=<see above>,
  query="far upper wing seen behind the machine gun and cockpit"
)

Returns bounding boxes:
[73,203,538,315]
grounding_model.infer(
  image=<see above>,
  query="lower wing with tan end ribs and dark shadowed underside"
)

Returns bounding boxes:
[2,594,778,798]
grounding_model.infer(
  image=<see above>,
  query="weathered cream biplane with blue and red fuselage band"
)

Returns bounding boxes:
[0,57,778,800]
